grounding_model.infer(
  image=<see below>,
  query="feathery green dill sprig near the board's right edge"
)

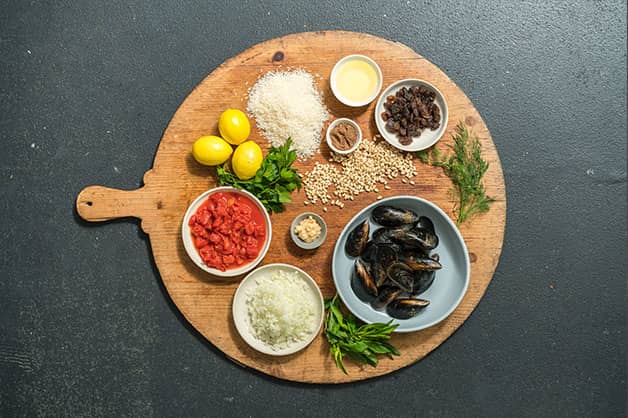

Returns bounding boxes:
[417,122,495,225]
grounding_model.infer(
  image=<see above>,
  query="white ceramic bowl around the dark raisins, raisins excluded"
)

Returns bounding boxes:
[373,78,448,152]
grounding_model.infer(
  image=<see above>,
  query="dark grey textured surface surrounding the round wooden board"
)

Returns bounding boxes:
[0,0,626,417]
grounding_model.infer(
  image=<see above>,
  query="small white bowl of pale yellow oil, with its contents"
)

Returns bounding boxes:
[330,55,382,107]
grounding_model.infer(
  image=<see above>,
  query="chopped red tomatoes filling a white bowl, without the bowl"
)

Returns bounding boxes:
[188,192,266,271]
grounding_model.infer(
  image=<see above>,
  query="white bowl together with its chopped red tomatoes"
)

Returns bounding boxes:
[181,187,272,277]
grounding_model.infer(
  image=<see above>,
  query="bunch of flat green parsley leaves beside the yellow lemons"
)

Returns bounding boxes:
[217,138,301,213]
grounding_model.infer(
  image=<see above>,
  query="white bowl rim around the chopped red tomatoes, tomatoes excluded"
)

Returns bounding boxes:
[181,186,273,277]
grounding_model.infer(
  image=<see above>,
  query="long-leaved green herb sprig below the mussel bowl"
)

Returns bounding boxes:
[323,294,400,374]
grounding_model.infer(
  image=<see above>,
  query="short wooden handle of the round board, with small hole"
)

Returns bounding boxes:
[76,186,146,222]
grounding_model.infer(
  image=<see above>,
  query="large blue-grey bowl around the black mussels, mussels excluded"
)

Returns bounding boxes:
[332,196,471,332]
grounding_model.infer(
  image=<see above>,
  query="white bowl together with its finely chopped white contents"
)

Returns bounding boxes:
[232,263,325,356]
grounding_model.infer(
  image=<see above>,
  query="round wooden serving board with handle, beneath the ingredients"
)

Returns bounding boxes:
[76,31,506,383]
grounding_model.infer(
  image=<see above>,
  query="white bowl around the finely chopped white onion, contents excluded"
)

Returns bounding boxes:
[232,263,325,356]
